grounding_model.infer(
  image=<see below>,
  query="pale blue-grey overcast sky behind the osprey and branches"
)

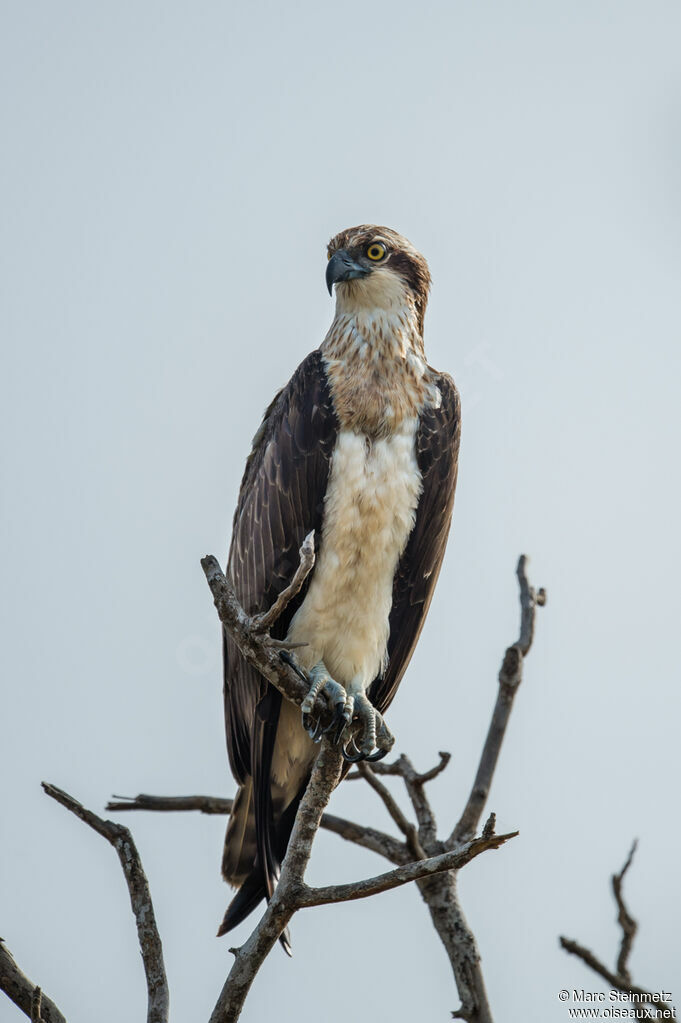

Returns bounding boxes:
[0,0,681,1023]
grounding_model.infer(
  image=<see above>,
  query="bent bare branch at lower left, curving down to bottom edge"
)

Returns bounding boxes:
[42,782,170,1023]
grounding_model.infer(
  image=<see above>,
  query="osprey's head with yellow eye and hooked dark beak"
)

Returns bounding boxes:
[326,224,430,336]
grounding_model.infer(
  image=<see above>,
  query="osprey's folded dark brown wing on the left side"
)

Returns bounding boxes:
[224,350,337,785]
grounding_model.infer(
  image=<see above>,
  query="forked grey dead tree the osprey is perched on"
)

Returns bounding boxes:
[125,552,545,1023]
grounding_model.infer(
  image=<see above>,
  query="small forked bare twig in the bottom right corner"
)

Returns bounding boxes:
[559,841,676,1019]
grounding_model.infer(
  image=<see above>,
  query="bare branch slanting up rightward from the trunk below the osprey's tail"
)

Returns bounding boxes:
[300,832,518,905]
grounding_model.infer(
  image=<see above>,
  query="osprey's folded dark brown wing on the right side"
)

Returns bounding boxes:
[369,373,461,714]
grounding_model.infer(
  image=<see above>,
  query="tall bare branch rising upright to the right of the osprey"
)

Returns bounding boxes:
[447,554,546,846]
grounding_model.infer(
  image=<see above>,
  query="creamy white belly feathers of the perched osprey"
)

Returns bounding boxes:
[288,418,421,687]
